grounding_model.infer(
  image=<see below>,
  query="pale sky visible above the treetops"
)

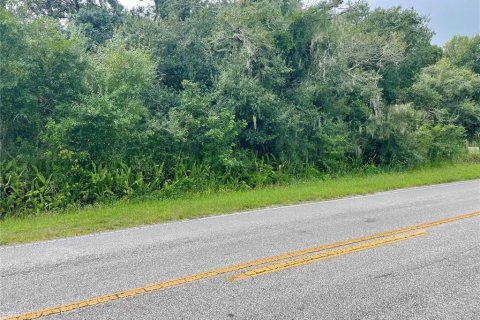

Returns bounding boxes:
[119,0,480,46]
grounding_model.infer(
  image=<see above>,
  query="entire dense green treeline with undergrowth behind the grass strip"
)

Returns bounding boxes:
[0,0,480,217]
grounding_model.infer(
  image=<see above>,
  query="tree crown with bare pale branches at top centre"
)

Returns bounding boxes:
[209,0,291,89]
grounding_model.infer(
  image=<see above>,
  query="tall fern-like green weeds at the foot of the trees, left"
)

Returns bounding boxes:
[0,155,318,217]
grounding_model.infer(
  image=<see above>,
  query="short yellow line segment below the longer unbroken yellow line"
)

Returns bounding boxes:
[228,230,427,281]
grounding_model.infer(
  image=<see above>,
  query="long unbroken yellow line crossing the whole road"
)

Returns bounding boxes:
[1,211,480,320]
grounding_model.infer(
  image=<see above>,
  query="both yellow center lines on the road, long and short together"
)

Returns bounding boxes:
[2,211,480,320]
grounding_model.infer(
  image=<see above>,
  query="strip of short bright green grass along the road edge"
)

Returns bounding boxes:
[0,163,480,245]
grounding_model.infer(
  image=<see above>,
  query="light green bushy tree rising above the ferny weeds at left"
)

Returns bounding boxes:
[48,38,156,161]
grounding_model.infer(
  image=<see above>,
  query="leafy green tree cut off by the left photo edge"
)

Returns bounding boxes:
[0,11,86,158]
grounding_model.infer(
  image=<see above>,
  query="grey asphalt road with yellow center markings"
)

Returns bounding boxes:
[0,180,480,320]
